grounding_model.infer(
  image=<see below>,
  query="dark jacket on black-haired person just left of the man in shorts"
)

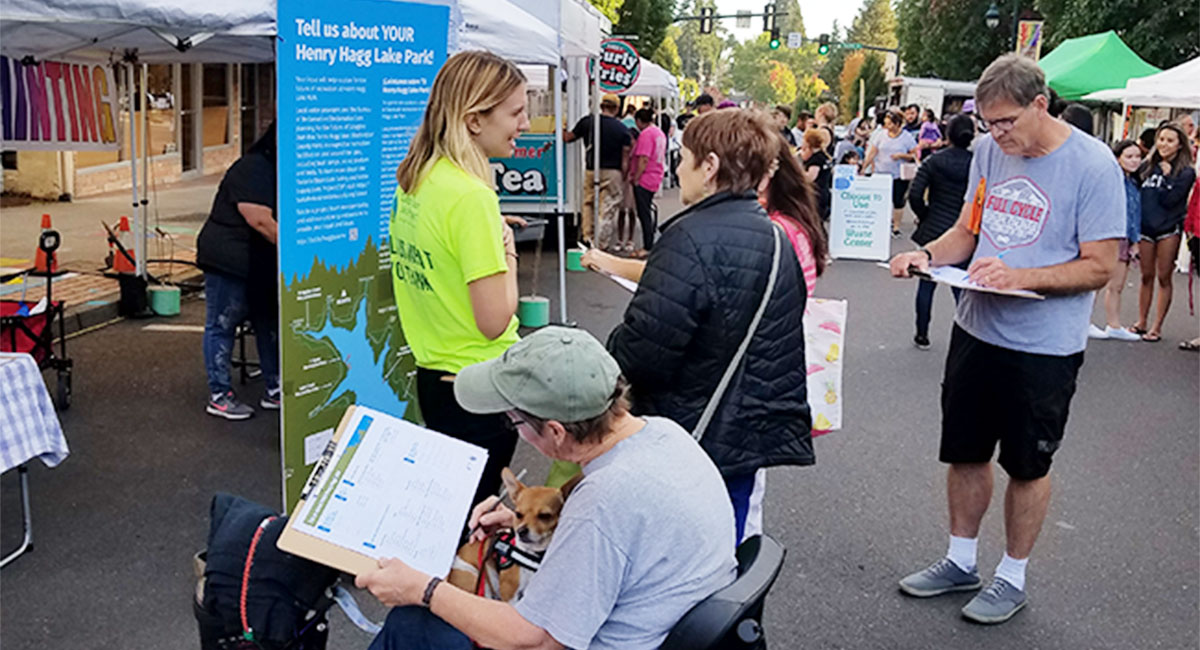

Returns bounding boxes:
[908,146,971,246]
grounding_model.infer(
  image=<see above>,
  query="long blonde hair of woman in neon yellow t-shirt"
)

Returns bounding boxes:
[396,50,526,194]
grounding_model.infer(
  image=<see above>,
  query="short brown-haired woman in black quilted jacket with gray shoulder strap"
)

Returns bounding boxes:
[586,109,814,541]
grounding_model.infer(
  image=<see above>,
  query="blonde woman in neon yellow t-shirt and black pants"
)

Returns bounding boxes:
[389,52,529,502]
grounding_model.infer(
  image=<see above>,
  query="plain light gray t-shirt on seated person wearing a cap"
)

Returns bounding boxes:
[516,417,737,649]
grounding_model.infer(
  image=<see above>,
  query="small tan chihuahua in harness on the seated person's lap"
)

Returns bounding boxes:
[446,468,583,603]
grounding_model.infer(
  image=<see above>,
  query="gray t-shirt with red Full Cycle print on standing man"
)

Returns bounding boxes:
[955,127,1126,356]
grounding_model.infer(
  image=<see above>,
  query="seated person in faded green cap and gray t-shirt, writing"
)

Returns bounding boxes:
[355,327,737,650]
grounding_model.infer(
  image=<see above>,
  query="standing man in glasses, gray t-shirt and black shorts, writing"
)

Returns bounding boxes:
[892,55,1124,624]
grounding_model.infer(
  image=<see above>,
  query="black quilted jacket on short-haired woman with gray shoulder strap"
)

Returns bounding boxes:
[608,193,815,477]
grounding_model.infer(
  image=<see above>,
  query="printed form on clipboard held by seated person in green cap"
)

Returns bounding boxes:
[278,407,487,576]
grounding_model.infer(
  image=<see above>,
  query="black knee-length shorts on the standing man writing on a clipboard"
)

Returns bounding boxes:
[938,325,1084,481]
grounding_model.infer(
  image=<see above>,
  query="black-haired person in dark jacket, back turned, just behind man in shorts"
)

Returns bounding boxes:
[908,115,974,350]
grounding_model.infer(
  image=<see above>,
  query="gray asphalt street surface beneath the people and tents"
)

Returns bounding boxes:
[0,221,1200,650]
